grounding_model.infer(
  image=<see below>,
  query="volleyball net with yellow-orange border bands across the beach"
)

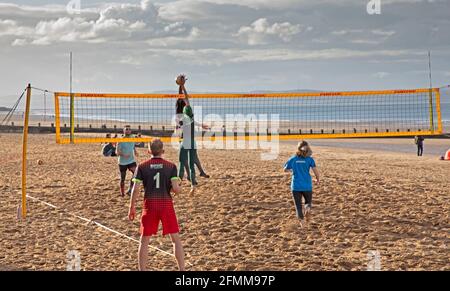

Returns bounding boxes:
[55,88,442,144]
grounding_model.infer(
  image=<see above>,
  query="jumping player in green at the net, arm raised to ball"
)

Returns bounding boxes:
[177,75,209,195]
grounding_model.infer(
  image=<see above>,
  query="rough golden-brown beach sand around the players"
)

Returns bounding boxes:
[0,134,450,270]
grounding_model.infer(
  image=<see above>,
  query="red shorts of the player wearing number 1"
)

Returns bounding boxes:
[141,199,180,236]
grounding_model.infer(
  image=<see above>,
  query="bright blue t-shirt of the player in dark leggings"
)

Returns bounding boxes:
[284,155,316,191]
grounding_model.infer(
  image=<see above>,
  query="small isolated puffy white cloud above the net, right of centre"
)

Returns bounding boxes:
[236,18,301,45]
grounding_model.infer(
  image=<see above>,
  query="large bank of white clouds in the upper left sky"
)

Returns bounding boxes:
[0,0,193,45]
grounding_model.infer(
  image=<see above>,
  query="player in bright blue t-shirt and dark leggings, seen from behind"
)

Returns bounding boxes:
[284,141,320,226]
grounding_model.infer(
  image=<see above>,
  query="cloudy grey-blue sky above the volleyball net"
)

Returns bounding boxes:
[0,0,450,98]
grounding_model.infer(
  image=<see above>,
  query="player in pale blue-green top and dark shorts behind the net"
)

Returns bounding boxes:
[116,125,138,196]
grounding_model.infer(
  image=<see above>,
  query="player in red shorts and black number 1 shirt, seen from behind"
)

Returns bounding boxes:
[128,139,185,271]
